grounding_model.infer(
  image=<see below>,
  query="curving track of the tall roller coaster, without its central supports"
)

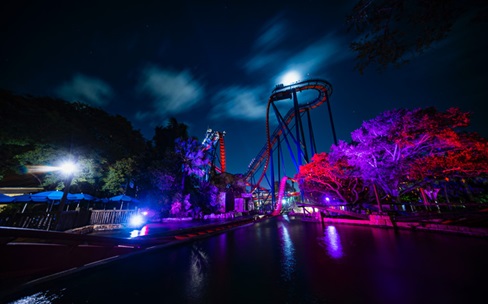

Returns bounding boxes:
[245,79,337,192]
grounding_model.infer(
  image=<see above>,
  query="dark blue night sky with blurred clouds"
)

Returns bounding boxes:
[0,0,488,173]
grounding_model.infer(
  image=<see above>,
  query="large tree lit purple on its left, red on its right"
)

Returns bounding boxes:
[336,107,487,207]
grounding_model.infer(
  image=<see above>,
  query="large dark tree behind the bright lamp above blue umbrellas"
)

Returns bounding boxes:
[0,91,146,195]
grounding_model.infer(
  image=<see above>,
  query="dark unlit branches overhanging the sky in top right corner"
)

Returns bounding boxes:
[347,0,488,74]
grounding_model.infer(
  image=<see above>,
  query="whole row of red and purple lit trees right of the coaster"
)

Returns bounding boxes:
[297,107,488,207]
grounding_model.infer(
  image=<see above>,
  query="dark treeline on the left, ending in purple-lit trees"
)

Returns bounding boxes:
[0,91,243,215]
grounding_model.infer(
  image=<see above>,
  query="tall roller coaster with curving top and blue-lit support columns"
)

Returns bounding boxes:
[245,79,337,211]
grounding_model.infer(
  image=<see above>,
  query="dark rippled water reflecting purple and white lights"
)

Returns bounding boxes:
[3,216,488,304]
